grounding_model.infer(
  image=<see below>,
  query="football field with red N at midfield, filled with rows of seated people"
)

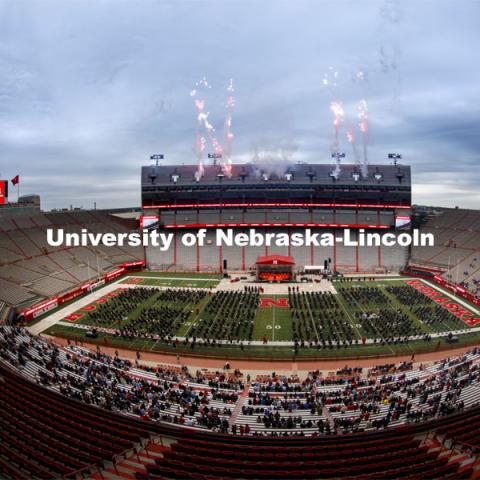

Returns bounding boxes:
[41,272,476,358]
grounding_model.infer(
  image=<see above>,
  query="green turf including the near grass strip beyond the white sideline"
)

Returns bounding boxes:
[44,272,480,358]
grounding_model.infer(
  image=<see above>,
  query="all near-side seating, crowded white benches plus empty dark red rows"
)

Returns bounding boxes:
[0,327,480,480]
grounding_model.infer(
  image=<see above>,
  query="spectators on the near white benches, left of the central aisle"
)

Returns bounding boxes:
[0,327,243,431]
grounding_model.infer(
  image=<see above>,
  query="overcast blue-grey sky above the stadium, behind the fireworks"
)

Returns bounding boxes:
[0,0,480,209]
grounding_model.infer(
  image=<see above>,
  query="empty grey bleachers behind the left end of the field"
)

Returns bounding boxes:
[0,210,143,305]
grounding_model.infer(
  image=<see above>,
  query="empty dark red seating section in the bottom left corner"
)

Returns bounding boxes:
[0,364,149,480]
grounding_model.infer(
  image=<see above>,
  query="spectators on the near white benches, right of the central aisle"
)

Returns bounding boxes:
[242,349,480,434]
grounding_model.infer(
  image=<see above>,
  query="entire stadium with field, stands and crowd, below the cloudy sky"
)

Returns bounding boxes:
[0,157,480,480]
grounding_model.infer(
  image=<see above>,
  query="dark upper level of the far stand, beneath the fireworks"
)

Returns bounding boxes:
[142,163,411,209]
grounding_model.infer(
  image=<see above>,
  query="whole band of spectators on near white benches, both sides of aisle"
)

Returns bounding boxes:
[0,327,480,435]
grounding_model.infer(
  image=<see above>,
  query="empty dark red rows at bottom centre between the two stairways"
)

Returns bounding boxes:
[142,435,457,479]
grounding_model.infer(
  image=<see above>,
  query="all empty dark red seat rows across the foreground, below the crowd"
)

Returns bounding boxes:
[0,354,480,480]
